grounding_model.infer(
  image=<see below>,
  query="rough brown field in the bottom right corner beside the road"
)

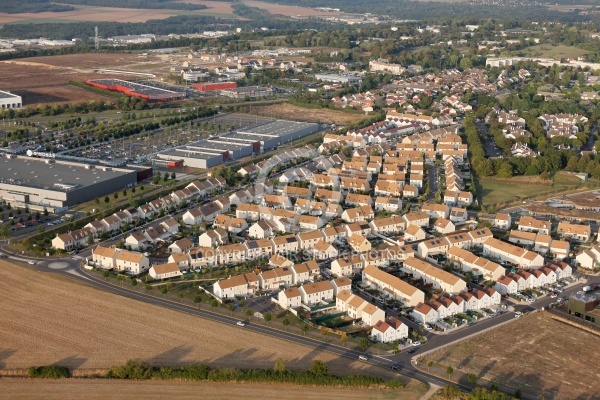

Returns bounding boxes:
[427,312,600,399]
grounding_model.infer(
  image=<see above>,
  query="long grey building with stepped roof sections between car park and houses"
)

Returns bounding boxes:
[157,120,319,169]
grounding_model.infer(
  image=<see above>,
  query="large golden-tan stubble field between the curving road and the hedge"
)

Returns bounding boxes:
[0,261,412,384]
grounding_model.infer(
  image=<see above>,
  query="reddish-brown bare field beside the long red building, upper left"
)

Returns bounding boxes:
[0,54,169,106]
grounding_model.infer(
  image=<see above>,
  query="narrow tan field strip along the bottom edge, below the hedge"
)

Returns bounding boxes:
[0,379,418,400]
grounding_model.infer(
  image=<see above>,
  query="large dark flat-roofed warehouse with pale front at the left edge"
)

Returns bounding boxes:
[0,155,152,212]
